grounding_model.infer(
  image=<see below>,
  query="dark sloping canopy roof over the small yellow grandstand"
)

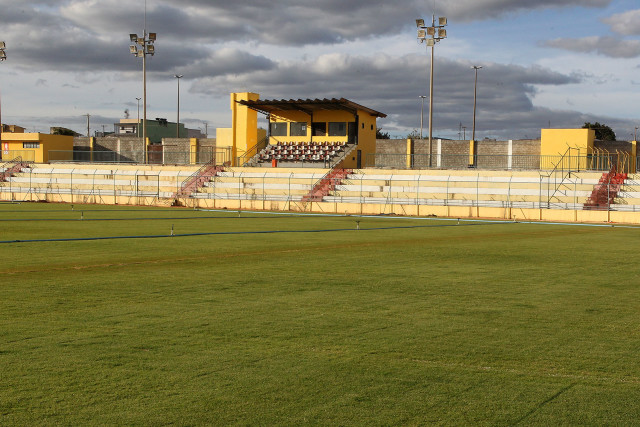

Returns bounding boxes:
[237,98,387,118]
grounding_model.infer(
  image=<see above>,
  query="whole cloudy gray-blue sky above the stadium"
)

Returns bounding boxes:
[0,0,640,139]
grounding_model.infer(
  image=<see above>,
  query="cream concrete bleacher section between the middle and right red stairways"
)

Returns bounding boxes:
[325,169,601,209]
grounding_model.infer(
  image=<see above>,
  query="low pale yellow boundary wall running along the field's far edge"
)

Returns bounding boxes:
[5,192,640,225]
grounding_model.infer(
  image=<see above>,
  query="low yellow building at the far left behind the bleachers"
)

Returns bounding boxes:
[2,133,73,163]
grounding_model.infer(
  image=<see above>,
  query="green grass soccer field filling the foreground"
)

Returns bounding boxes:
[0,203,640,425]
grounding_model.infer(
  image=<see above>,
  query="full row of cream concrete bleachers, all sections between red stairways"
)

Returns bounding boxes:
[0,164,640,217]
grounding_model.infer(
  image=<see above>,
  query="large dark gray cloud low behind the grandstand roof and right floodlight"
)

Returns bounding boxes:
[191,54,582,136]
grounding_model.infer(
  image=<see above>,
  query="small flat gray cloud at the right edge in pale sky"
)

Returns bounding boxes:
[544,37,640,58]
